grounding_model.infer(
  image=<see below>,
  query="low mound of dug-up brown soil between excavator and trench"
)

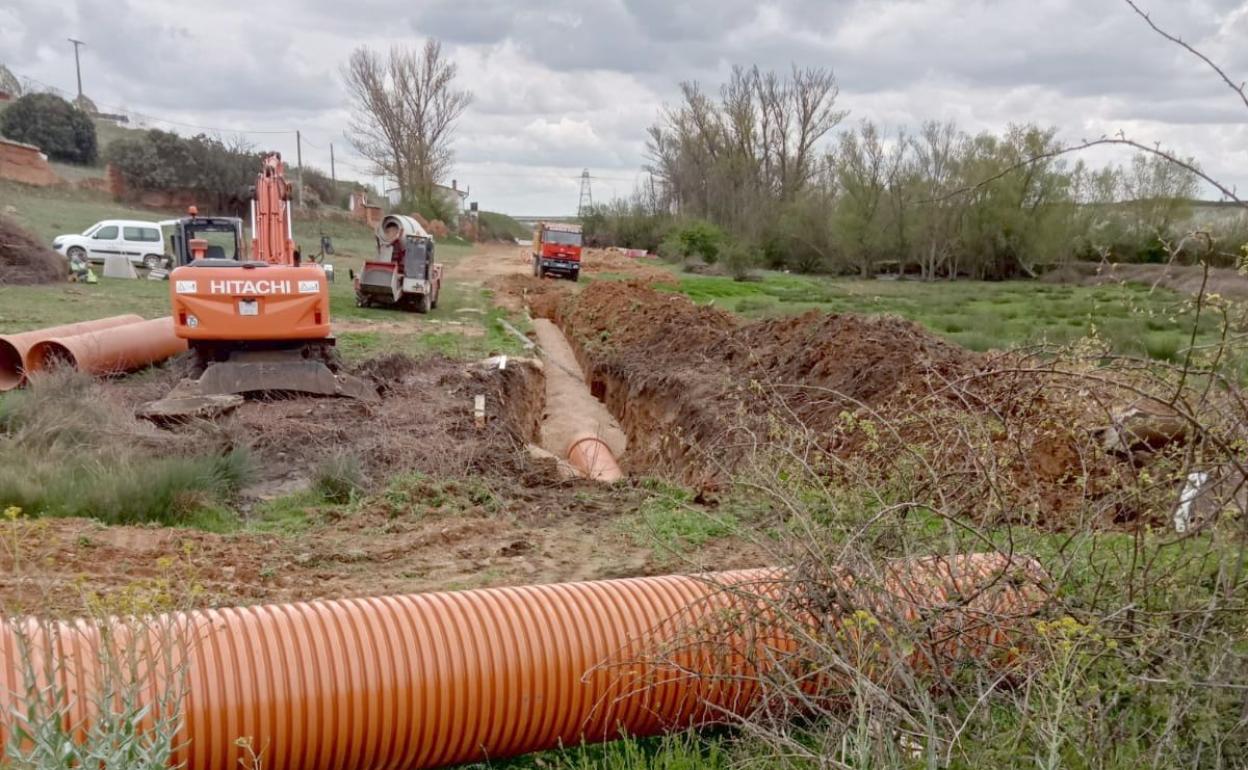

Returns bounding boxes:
[111,354,543,489]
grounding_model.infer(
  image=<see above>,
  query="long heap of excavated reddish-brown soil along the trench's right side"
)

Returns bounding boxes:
[554,282,1153,527]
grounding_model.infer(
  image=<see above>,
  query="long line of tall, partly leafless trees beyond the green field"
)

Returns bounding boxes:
[585,67,1248,280]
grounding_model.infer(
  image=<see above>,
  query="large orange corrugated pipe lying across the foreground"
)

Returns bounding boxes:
[0,554,1045,770]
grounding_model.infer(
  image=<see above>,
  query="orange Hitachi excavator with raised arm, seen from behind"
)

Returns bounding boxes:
[154,154,377,411]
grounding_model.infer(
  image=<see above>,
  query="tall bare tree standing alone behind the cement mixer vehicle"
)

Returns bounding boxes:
[342,40,472,201]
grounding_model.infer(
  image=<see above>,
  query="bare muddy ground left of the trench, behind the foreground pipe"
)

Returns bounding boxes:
[0,239,765,614]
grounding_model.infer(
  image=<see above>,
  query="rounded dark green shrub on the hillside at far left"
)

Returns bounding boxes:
[0,94,99,165]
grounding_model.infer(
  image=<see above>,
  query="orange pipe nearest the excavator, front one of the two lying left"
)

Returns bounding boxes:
[26,316,186,374]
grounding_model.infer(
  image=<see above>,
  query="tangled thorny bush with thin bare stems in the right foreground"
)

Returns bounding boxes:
[616,263,1248,770]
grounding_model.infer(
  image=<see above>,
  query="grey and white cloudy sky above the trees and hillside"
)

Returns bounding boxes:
[0,0,1248,215]
